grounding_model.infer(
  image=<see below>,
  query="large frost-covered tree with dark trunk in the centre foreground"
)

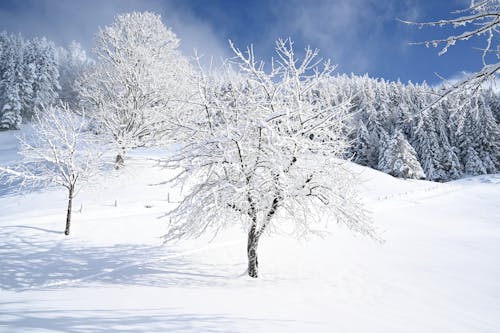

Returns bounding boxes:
[165,40,375,278]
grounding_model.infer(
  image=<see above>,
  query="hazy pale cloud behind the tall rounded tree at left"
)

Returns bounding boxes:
[0,0,228,58]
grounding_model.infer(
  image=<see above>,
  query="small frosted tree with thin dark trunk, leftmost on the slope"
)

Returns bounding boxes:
[0,105,100,235]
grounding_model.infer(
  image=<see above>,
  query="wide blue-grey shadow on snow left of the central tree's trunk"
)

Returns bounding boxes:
[0,226,240,291]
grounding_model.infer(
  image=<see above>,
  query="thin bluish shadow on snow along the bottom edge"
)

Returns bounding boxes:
[0,306,314,333]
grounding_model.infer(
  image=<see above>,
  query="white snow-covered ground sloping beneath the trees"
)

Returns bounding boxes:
[0,128,500,333]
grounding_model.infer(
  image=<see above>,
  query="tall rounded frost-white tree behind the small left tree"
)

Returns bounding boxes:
[80,12,193,167]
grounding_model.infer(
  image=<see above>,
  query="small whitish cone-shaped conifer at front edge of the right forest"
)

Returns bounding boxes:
[378,130,425,179]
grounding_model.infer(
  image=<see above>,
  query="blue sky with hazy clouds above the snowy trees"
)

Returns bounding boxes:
[0,0,483,84]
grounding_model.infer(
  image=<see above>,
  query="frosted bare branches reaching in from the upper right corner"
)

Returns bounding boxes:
[402,0,500,98]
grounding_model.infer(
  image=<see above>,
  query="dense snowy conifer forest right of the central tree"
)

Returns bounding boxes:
[326,75,500,181]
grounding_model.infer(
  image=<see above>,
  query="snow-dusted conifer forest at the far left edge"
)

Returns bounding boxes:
[0,31,92,130]
